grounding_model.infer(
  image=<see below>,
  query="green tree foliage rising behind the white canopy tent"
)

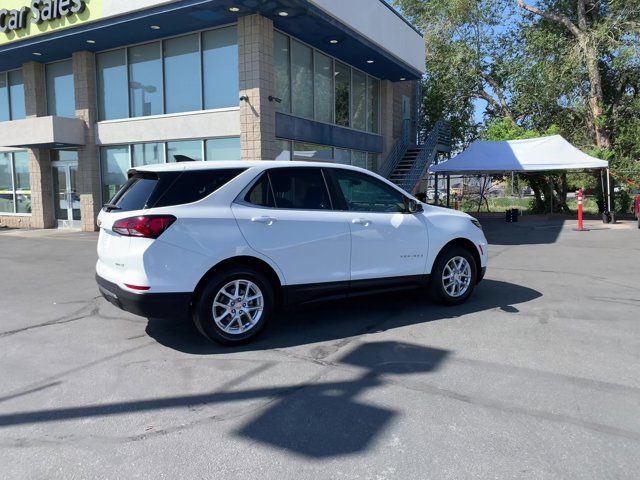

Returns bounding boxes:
[394,0,640,180]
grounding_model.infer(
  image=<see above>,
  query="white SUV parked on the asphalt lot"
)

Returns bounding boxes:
[96,161,487,344]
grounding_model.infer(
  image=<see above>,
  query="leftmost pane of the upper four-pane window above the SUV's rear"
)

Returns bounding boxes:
[96,49,129,120]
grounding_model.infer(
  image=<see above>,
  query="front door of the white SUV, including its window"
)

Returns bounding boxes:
[326,168,429,282]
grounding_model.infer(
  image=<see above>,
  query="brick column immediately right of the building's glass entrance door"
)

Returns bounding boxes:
[73,52,102,232]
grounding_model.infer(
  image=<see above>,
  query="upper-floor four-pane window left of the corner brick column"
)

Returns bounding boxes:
[97,26,240,120]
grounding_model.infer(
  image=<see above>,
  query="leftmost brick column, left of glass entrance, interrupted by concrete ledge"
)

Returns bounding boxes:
[22,62,57,228]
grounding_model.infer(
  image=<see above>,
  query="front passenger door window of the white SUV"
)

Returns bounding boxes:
[332,169,407,213]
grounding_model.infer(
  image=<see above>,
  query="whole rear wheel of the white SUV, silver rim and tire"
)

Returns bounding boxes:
[193,267,274,345]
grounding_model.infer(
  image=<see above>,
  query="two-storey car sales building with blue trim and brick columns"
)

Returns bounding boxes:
[0,0,424,231]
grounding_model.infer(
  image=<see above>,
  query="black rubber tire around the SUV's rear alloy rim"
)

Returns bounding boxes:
[193,266,274,345]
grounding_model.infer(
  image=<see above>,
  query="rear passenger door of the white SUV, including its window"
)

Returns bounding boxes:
[232,167,351,293]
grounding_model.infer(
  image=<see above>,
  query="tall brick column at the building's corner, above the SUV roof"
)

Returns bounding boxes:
[238,15,276,160]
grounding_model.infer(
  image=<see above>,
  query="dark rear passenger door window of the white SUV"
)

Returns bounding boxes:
[269,168,331,210]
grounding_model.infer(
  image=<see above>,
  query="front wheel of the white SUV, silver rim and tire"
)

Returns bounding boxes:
[430,247,478,305]
